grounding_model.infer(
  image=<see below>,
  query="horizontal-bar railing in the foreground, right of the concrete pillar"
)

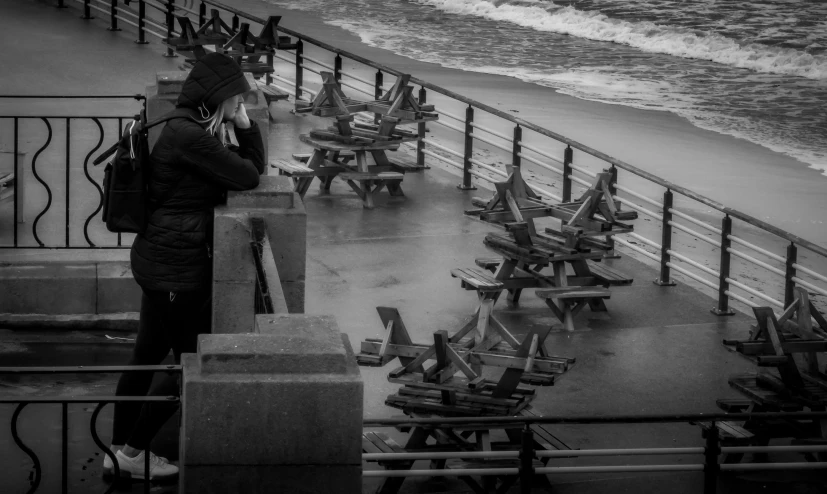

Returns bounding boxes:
[362,412,827,494]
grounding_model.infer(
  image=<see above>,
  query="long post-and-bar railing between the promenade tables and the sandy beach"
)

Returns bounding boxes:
[43,0,827,315]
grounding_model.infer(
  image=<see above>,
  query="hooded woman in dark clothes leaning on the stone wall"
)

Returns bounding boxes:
[104,53,264,479]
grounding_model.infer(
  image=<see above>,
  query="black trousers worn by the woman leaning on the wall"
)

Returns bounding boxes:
[112,288,212,450]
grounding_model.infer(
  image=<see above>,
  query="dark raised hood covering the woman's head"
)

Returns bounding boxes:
[178,53,250,114]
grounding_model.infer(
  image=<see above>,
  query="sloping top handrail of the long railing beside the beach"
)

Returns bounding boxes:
[197,0,827,257]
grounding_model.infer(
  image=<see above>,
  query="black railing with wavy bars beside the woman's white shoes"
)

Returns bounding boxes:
[0,365,182,494]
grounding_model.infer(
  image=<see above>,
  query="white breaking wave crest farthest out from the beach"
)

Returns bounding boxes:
[415,0,827,79]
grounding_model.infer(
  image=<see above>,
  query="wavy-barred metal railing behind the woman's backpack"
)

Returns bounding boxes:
[0,94,146,249]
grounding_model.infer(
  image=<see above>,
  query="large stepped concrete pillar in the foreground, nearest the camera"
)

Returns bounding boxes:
[179,314,364,494]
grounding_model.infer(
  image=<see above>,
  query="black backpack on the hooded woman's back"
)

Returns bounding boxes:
[93,109,195,233]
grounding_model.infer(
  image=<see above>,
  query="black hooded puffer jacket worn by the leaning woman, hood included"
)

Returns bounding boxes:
[130,54,264,292]
